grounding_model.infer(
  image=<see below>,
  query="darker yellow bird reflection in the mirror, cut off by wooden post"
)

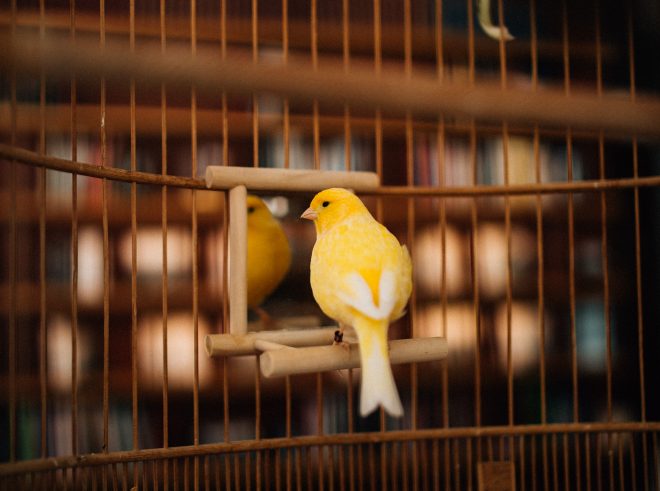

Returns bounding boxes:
[247,195,291,323]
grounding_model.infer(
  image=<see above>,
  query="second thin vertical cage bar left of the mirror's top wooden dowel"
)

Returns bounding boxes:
[160,0,170,489]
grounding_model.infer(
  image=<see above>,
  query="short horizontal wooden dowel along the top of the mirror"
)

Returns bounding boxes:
[206,165,379,191]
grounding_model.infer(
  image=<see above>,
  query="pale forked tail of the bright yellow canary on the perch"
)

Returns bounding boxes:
[353,318,403,417]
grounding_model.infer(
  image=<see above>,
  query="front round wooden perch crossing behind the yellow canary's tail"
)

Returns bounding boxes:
[259,338,447,377]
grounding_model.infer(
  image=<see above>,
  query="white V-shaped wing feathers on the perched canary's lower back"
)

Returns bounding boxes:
[337,269,397,320]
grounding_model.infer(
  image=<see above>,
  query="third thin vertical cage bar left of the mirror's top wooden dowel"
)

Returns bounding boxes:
[129,0,139,487]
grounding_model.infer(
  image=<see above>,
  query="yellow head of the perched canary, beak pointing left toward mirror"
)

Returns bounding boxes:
[300,188,369,234]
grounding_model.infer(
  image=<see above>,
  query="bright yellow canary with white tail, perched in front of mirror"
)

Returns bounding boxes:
[302,188,412,416]
